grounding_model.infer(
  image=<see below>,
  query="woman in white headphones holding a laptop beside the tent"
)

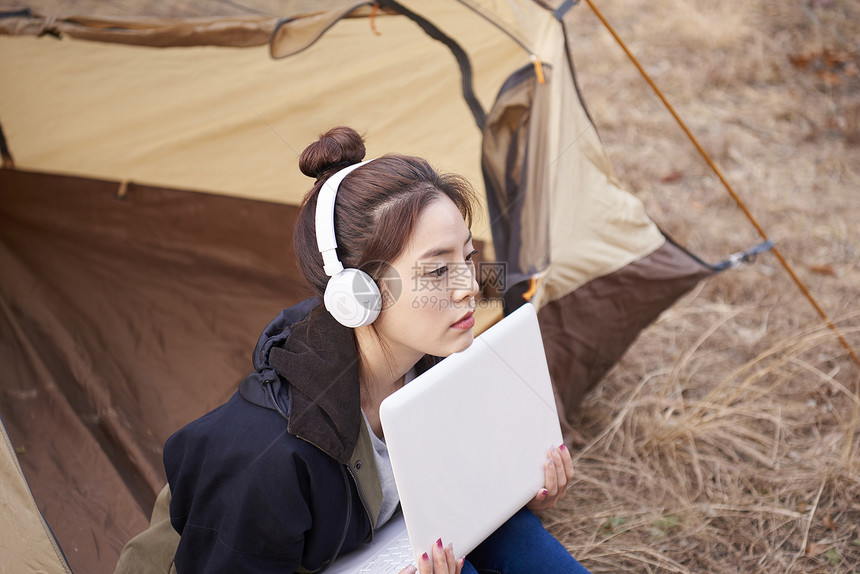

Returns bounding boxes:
[158,127,585,574]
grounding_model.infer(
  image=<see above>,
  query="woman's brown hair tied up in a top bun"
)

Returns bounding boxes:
[293,127,475,297]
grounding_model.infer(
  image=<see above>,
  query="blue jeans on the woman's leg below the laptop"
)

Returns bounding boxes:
[462,508,588,574]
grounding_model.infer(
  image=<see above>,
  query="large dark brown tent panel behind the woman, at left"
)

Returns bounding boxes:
[0,170,306,572]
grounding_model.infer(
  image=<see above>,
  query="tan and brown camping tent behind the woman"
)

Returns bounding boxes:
[0,0,714,572]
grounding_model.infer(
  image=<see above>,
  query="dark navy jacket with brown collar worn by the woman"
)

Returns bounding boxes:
[164,299,438,574]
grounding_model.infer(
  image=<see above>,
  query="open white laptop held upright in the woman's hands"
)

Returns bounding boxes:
[327,303,562,574]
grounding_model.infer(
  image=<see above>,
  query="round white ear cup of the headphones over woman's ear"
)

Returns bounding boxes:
[323,269,382,328]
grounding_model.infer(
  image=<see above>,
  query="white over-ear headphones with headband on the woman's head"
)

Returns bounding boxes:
[316,159,382,327]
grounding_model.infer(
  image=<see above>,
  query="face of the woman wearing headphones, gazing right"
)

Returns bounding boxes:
[374,194,478,361]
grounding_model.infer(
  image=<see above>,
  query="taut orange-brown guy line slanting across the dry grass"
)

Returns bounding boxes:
[585,0,860,374]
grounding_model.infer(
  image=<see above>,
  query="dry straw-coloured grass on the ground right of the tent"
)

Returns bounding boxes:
[544,0,860,574]
